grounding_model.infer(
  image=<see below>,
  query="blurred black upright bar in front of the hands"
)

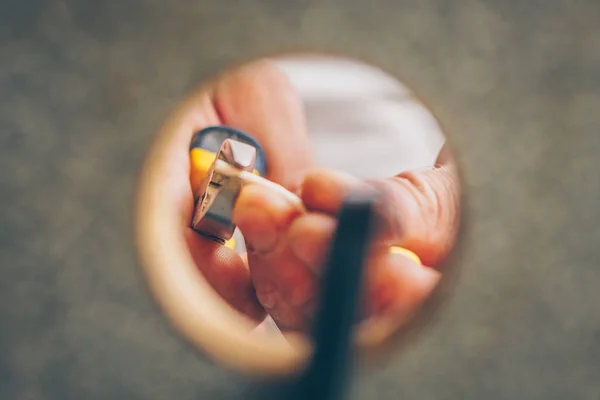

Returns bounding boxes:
[293,192,377,400]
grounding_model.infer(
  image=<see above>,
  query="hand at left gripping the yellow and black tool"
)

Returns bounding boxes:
[173,60,313,319]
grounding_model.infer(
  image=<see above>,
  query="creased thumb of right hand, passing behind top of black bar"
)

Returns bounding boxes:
[302,164,460,266]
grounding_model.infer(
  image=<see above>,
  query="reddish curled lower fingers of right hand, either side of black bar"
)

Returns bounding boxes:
[234,181,439,331]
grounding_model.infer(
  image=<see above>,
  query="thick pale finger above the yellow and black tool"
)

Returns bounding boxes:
[212,60,314,191]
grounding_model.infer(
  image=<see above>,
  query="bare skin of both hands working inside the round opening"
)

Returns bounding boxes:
[171,60,459,331]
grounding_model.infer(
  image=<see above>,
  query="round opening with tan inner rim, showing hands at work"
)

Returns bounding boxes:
[137,55,461,374]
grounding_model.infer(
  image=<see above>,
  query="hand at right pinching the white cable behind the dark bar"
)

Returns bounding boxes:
[234,147,459,331]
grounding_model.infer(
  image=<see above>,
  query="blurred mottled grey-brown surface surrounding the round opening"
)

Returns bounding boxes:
[0,0,600,400]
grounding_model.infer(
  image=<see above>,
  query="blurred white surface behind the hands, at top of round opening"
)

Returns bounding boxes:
[278,57,445,178]
